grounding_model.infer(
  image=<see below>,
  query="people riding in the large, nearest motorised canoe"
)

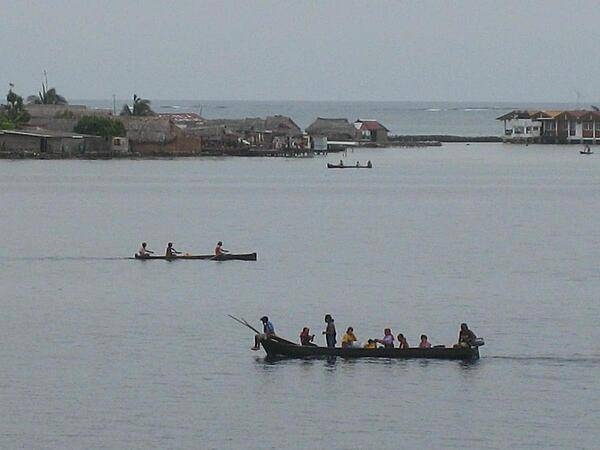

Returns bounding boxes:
[252,314,477,350]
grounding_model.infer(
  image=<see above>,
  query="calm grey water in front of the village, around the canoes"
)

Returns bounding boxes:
[0,144,600,449]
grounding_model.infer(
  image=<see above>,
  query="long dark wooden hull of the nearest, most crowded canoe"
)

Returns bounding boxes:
[261,339,479,361]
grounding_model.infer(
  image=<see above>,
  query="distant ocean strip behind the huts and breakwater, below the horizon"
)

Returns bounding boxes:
[81,100,590,136]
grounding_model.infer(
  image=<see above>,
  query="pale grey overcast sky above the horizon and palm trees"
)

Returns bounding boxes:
[0,0,600,103]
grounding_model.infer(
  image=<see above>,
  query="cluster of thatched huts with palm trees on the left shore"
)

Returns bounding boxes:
[0,85,389,159]
